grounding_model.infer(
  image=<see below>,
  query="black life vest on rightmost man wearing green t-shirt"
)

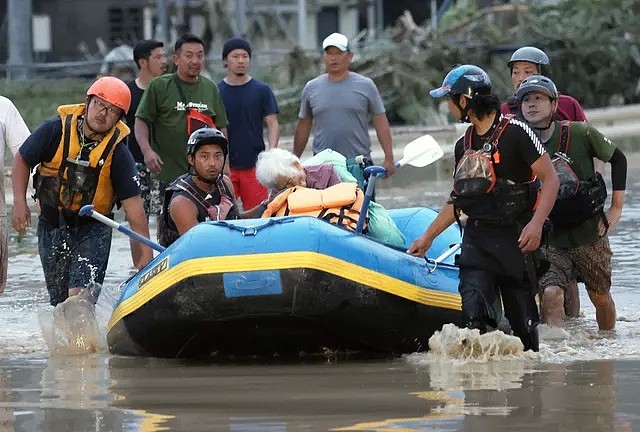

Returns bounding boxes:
[549,120,608,229]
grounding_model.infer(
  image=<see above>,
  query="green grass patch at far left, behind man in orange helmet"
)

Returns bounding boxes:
[0,80,91,130]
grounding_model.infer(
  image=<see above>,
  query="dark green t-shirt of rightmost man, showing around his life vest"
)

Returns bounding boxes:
[544,121,616,249]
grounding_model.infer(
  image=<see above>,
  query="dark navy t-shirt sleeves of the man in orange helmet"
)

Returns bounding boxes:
[19,117,140,201]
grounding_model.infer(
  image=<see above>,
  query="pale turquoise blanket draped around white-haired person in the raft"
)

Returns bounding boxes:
[302,149,407,248]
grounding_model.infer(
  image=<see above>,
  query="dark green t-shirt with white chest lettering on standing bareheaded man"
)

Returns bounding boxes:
[136,74,229,183]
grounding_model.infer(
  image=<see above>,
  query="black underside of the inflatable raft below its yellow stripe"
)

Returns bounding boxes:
[108,269,461,358]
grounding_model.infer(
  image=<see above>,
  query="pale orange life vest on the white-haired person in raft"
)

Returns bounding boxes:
[262,182,367,231]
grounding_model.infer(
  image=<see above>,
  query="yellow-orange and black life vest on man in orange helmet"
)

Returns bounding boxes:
[36,104,130,215]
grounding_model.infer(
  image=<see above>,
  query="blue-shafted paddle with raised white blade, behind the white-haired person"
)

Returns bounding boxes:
[356,134,444,234]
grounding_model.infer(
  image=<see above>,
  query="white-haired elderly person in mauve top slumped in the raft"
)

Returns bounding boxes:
[256,148,341,196]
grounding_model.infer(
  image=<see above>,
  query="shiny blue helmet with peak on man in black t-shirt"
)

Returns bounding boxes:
[429,65,491,99]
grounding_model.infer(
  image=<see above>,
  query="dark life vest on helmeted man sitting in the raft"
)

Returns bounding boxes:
[160,173,240,247]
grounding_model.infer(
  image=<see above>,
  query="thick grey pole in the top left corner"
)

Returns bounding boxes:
[7,0,33,81]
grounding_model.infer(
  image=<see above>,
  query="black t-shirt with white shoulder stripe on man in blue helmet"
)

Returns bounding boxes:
[455,116,546,183]
